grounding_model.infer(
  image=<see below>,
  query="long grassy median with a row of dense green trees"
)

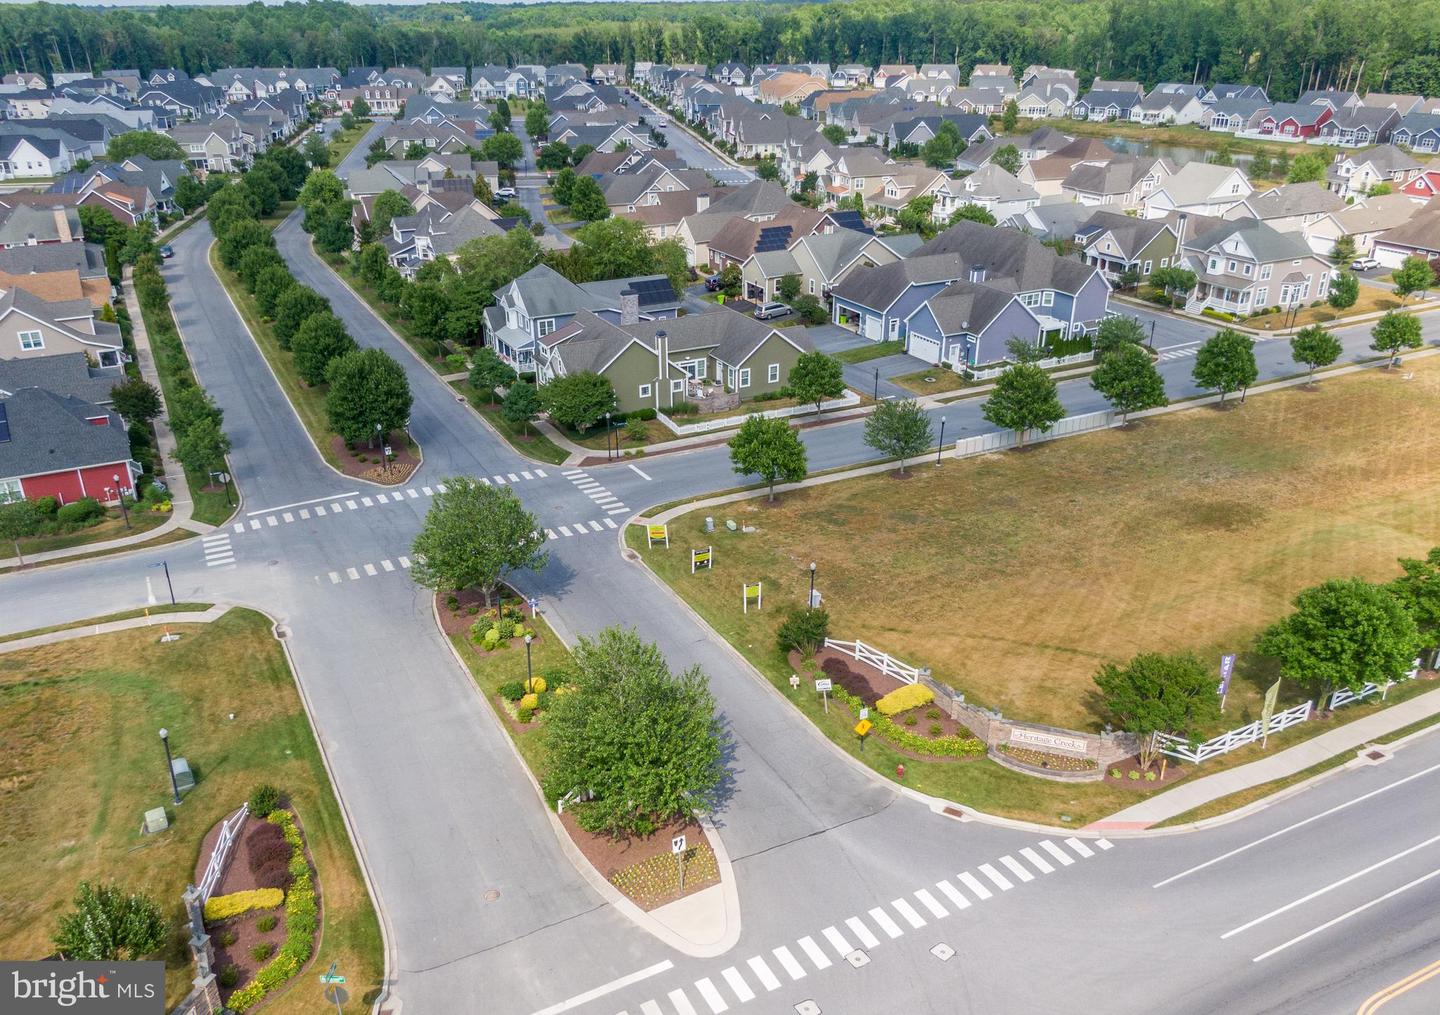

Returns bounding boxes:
[209,164,420,485]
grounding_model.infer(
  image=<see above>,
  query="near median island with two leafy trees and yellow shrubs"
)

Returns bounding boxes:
[412,478,724,910]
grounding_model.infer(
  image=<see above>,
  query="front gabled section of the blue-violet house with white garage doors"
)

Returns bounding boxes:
[904,276,1043,366]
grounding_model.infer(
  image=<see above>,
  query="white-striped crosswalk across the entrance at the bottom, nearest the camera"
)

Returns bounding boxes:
[607,836,1115,1015]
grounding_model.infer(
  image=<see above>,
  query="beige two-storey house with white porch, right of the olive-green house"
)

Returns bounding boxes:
[1181,219,1331,315]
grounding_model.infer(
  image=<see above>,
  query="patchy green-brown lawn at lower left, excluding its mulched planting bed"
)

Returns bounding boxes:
[0,610,383,1012]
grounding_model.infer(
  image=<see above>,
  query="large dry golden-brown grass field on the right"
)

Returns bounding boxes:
[636,352,1440,730]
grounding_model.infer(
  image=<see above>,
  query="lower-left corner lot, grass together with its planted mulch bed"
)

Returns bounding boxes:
[0,608,383,1012]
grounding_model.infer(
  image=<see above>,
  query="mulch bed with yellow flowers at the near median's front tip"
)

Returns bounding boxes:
[560,811,720,910]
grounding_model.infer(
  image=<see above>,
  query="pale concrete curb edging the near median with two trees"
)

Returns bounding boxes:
[431,593,740,959]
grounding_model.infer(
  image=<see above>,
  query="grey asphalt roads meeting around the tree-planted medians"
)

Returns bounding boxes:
[0,222,1440,1015]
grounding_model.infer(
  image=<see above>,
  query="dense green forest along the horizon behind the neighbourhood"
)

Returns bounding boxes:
[8,0,1440,99]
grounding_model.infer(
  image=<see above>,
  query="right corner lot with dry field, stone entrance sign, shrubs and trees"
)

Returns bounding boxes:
[626,360,1440,824]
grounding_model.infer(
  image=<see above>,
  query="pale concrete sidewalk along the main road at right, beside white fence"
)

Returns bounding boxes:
[1084,679,1440,832]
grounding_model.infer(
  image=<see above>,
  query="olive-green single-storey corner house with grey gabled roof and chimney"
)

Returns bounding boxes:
[537,307,814,412]
